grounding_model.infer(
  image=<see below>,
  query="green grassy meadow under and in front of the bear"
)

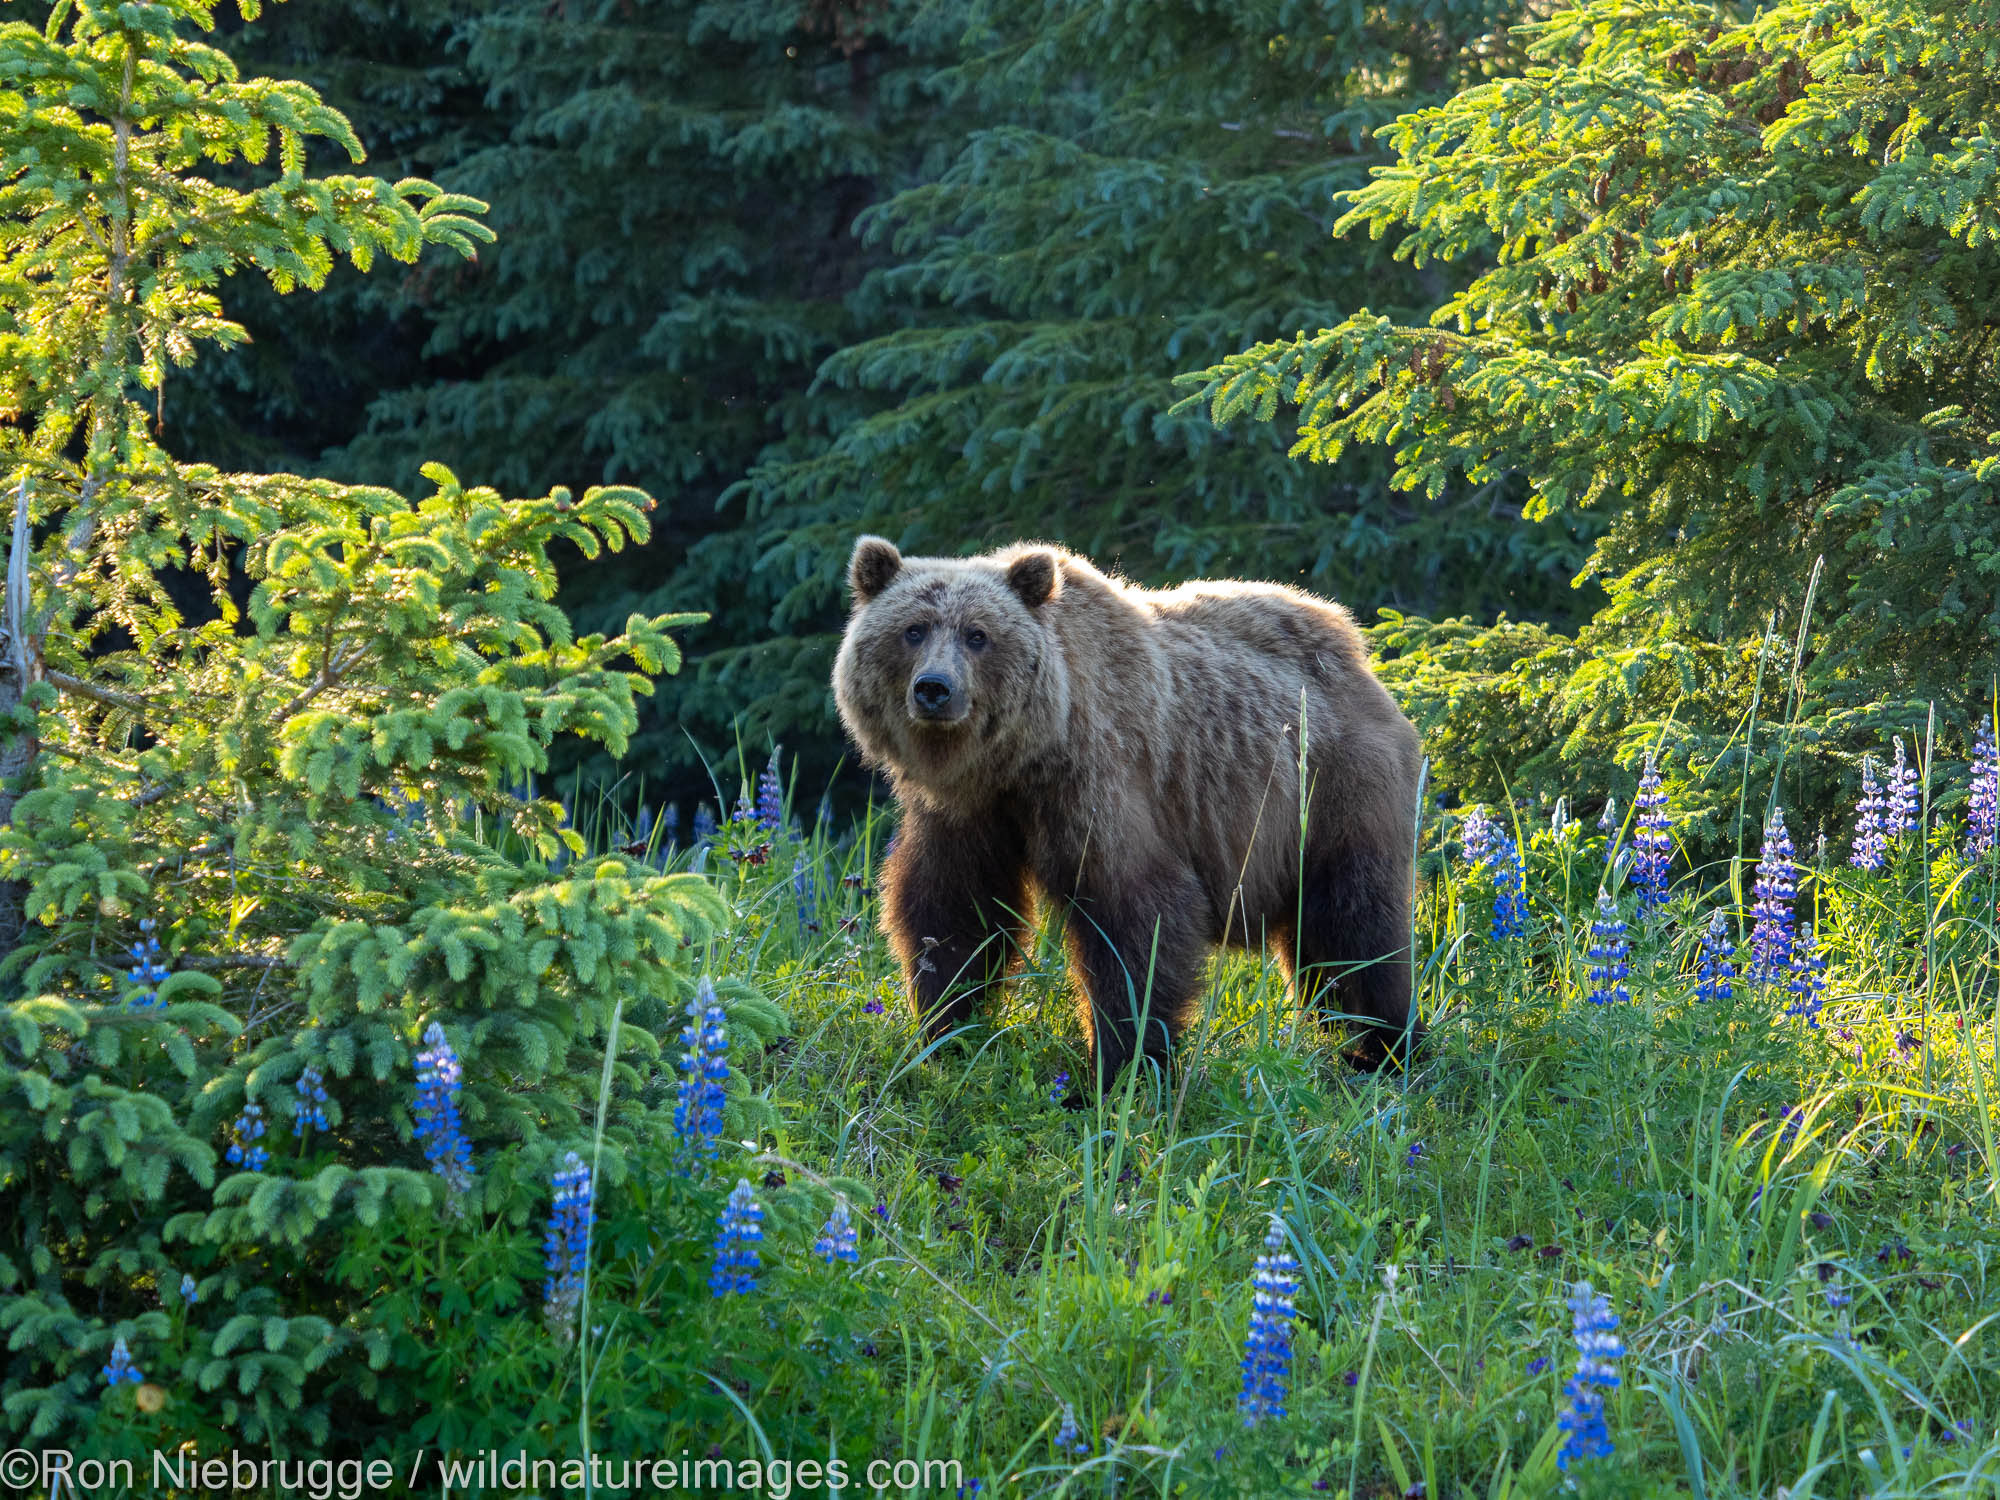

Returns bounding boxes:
[594,792,2000,1500]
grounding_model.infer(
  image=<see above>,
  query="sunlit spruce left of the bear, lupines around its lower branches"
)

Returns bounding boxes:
[0,0,776,1458]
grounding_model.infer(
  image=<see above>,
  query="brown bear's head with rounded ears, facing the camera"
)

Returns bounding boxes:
[834,536,1070,806]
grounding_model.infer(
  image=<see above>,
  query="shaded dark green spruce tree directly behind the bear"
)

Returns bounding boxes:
[672,0,1588,792]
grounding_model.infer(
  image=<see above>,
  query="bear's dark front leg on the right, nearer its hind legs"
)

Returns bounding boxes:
[1066,868,1210,1092]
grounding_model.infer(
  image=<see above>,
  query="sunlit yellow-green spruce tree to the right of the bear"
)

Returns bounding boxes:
[1192,0,2000,828]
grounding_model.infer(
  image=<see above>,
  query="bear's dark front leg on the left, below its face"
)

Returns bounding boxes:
[882,808,1028,1042]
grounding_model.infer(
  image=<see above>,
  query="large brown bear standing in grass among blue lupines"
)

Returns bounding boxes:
[834,536,1420,1088]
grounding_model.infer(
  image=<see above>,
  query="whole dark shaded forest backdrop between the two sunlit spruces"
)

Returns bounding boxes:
[184,0,1598,816]
